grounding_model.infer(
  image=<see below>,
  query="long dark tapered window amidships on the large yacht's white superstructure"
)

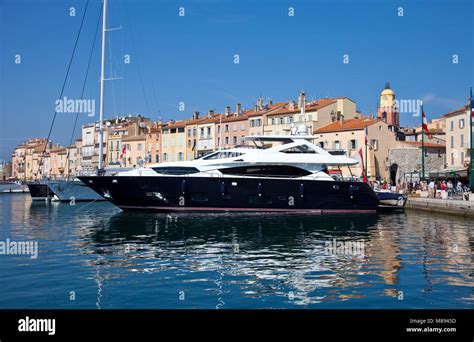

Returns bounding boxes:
[219,165,311,178]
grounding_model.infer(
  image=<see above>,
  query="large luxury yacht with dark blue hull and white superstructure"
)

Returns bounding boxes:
[79,135,379,213]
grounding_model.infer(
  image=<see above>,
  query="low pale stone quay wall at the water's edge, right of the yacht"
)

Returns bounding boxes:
[405,197,474,218]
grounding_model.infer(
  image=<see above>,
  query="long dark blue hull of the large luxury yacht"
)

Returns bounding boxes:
[79,176,379,213]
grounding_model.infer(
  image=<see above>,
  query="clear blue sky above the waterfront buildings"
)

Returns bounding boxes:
[0,0,474,159]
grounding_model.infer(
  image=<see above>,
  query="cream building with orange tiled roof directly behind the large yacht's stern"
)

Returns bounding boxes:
[314,117,397,181]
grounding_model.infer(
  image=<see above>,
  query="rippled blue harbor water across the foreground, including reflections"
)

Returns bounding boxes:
[0,194,474,309]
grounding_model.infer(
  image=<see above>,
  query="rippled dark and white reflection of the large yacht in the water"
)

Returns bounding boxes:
[81,212,378,307]
